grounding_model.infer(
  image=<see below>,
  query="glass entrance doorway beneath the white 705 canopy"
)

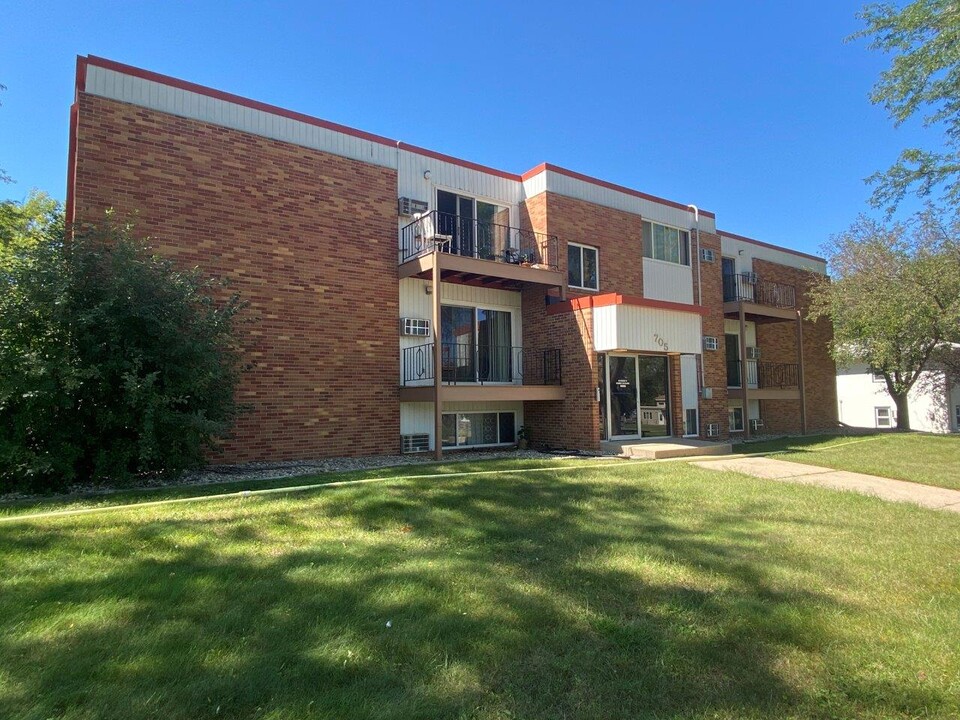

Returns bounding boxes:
[606,355,670,440]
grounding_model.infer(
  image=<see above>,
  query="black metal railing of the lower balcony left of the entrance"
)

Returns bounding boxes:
[403,343,561,385]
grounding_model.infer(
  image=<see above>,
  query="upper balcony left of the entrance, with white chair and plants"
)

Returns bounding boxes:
[399,210,564,290]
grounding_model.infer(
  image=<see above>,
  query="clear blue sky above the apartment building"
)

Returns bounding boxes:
[0,0,940,252]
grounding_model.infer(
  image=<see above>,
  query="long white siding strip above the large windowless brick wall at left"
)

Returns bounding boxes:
[86,64,397,168]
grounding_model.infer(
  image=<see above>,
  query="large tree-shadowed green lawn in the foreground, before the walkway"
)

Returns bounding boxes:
[0,462,960,719]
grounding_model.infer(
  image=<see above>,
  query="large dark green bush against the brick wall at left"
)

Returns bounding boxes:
[0,217,248,491]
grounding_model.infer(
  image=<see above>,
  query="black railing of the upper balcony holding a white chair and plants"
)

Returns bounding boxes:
[400,210,559,270]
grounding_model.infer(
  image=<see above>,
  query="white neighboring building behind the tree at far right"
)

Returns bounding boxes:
[837,365,960,433]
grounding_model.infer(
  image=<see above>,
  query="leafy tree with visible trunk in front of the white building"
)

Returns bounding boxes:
[810,209,960,430]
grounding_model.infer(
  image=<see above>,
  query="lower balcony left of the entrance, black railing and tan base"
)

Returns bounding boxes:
[400,342,564,402]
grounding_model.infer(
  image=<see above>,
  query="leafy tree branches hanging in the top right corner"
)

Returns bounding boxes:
[853,0,960,213]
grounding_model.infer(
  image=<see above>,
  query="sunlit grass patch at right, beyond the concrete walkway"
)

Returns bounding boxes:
[734,433,960,490]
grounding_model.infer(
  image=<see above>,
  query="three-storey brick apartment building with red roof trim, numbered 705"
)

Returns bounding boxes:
[67,57,837,462]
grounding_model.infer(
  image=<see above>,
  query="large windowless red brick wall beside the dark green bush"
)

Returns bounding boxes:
[74,94,400,462]
